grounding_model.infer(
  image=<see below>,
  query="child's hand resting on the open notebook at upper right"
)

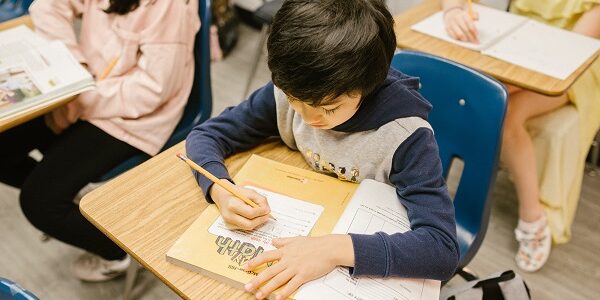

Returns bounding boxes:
[444,8,479,44]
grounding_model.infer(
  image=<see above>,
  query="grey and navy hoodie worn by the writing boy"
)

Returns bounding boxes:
[186,69,459,280]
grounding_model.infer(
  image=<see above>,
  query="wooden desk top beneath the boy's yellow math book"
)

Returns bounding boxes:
[80,140,309,299]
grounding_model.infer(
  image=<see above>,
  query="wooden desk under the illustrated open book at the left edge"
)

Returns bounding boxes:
[0,16,75,132]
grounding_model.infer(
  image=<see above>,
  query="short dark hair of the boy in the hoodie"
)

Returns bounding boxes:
[267,0,396,106]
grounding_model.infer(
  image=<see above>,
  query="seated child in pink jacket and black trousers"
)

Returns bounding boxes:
[0,0,200,281]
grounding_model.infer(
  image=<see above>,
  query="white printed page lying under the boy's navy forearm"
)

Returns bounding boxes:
[295,179,440,300]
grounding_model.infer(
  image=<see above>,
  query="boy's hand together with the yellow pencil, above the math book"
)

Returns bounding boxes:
[177,154,276,230]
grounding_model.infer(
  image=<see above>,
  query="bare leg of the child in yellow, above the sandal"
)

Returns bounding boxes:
[501,87,568,222]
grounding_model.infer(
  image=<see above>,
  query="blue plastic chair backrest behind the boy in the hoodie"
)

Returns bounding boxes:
[392,51,507,269]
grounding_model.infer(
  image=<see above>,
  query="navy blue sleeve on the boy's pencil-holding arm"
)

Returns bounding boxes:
[185,83,279,203]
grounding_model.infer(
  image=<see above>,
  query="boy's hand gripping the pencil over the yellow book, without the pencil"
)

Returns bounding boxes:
[209,179,271,230]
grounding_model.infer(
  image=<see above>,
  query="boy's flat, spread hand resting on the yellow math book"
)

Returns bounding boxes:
[244,234,354,300]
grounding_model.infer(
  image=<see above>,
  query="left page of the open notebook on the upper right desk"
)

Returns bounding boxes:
[411,4,527,51]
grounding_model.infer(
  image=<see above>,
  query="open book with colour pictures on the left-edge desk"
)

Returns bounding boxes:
[0,25,94,118]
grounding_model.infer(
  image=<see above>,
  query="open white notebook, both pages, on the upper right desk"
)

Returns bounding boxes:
[411,4,600,80]
